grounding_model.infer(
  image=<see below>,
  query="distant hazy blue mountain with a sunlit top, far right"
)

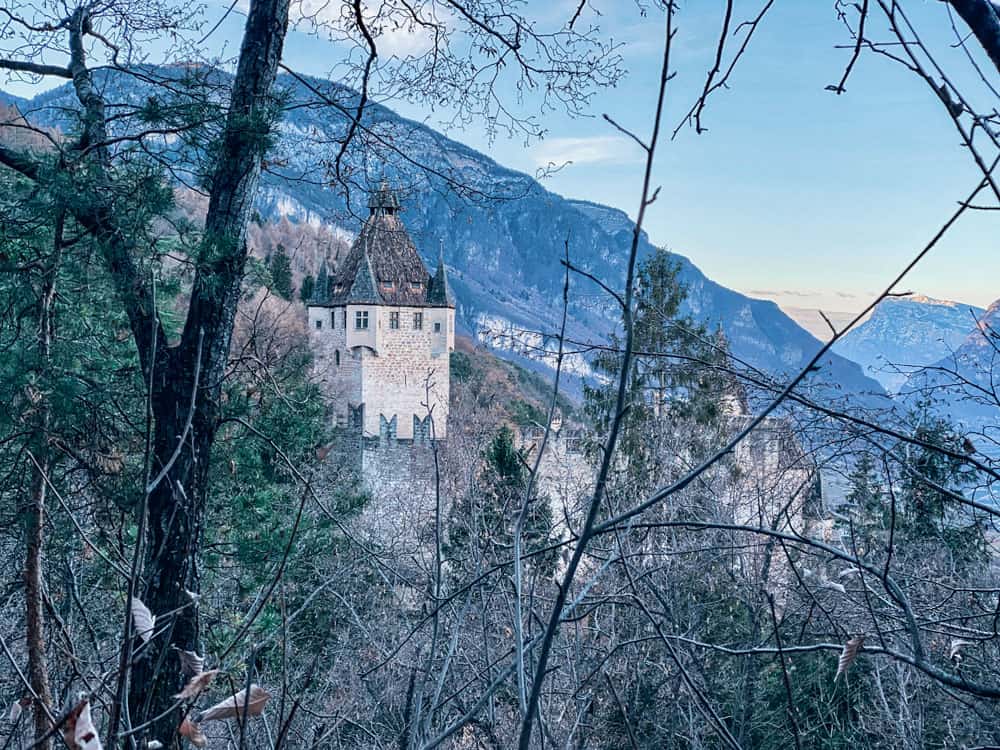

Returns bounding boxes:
[834,295,984,392]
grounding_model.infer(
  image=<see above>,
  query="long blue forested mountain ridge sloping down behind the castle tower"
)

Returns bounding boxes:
[3,68,883,402]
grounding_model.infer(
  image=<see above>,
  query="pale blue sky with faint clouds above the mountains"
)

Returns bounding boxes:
[3,0,1000,311]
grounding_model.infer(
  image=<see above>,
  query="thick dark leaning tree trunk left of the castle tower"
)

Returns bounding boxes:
[129,0,289,745]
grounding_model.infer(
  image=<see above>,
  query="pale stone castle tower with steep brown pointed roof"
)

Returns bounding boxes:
[307,183,455,494]
